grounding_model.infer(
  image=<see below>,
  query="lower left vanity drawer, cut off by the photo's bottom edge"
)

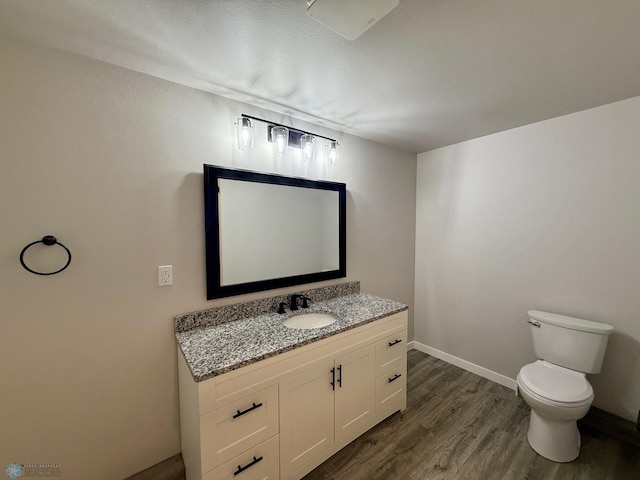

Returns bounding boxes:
[202,435,280,480]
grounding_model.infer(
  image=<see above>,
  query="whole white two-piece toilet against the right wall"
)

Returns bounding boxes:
[517,310,613,462]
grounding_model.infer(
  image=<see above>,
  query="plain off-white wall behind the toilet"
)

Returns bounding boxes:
[414,94,640,419]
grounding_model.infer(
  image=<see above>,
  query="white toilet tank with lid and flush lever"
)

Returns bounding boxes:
[527,310,613,373]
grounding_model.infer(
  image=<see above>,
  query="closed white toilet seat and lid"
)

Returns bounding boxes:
[518,360,593,407]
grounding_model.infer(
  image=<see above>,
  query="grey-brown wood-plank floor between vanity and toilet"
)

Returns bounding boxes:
[304,350,640,480]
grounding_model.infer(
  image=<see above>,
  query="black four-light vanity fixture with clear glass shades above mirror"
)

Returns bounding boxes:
[236,113,340,167]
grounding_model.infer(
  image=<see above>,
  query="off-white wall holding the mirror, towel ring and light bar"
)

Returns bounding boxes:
[0,38,416,480]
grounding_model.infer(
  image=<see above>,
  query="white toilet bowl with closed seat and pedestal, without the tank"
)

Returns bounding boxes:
[517,360,593,462]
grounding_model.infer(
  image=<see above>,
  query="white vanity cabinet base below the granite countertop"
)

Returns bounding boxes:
[178,311,407,480]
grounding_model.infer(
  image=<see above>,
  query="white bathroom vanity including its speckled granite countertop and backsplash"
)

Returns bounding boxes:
[175,282,408,480]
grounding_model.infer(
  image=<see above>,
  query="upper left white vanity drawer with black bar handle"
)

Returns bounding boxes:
[200,385,278,470]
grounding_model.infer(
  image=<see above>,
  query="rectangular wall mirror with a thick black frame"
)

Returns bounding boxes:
[204,165,346,300]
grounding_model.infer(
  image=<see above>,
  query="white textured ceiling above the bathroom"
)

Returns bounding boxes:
[0,0,640,153]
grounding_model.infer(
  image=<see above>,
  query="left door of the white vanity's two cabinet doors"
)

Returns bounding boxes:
[280,358,334,478]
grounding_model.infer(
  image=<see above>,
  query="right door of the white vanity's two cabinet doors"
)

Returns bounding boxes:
[335,344,376,445]
